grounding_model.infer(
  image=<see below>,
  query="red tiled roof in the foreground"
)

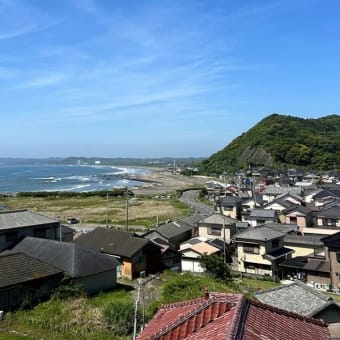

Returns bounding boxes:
[137,292,330,340]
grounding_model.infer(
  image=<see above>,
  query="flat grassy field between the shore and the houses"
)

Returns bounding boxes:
[0,194,192,228]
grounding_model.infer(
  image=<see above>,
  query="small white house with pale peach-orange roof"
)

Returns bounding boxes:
[179,238,221,273]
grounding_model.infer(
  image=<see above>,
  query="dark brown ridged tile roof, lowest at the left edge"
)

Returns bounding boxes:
[0,253,62,288]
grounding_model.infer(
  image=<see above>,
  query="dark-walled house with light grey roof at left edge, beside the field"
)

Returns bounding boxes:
[0,210,61,252]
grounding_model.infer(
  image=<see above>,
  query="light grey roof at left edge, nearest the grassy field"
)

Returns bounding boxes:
[0,210,59,230]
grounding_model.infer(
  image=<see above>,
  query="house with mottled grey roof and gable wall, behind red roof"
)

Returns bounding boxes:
[255,281,340,324]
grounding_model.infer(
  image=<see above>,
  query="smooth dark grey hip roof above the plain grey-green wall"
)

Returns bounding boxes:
[8,236,119,277]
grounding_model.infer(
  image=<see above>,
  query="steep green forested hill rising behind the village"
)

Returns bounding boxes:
[199,114,340,174]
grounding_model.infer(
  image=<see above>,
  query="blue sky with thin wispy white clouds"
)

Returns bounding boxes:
[0,0,340,158]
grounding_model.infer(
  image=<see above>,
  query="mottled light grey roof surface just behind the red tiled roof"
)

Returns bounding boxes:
[255,281,333,316]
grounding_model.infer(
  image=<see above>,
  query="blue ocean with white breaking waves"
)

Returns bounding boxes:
[0,165,149,194]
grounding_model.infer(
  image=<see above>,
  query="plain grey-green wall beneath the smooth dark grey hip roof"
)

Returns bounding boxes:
[78,268,117,294]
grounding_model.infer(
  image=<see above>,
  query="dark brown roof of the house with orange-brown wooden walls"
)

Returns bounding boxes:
[73,227,152,258]
